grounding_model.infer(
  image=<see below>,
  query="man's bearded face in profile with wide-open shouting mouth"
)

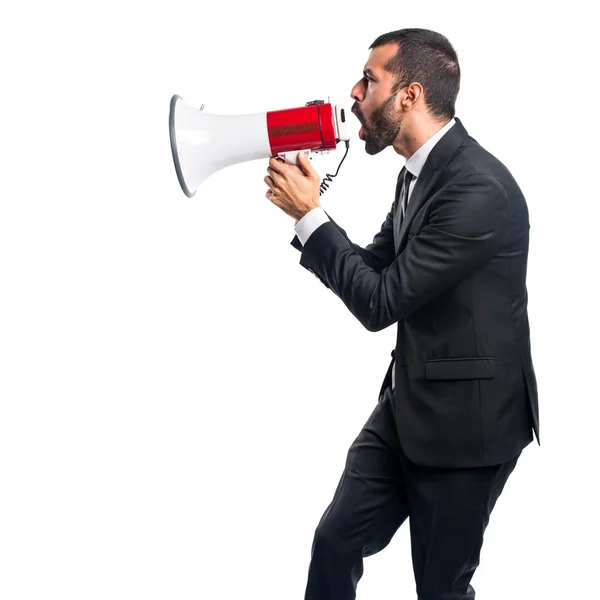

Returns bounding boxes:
[350,44,402,154]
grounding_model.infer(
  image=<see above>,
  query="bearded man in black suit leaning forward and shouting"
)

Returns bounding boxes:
[265,29,539,600]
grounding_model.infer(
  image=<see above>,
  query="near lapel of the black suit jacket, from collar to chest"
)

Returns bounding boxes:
[394,119,468,254]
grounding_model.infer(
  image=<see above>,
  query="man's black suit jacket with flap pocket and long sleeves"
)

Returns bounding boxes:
[291,119,540,467]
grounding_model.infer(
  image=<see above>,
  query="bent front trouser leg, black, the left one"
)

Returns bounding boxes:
[305,392,408,600]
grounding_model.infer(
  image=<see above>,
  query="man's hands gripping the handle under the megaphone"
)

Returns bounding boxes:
[265,152,321,221]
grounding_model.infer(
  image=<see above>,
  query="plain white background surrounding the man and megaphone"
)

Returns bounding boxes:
[0,0,600,600]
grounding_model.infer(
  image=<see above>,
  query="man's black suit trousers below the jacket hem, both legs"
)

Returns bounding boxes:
[305,386,520,600]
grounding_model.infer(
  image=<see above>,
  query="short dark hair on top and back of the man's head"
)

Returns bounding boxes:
[369,28,460,119]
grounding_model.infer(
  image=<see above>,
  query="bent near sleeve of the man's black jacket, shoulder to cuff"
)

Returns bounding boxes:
[300,173,508,331]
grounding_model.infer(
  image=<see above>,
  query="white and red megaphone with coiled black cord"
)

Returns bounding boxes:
[169,95,350,198]
